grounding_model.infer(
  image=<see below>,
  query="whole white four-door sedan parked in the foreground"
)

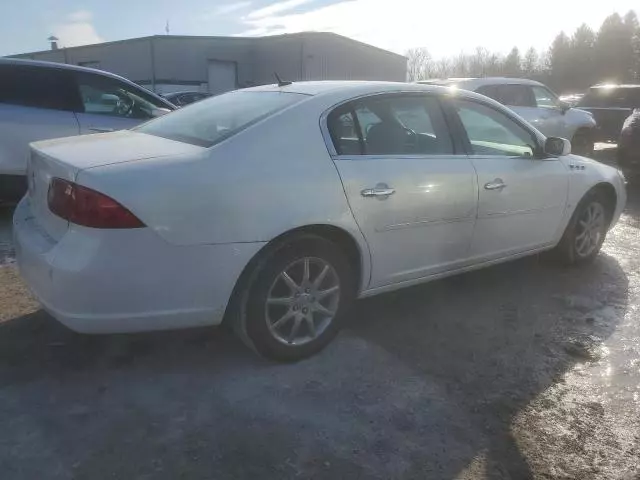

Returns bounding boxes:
[14,82,626,360]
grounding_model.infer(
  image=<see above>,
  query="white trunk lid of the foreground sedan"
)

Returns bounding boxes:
[27,131,203,241]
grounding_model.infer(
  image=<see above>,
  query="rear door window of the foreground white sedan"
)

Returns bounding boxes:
[328,95,453,155]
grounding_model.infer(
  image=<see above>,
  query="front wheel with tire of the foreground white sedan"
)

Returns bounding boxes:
[553,191,611,265]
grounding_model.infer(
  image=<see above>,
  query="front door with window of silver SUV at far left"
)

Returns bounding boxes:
[74,72,167,134]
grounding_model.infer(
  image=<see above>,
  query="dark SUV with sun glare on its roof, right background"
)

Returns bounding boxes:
[578,85,640,142]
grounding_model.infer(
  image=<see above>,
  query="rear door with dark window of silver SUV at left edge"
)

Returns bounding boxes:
[0,64,79,175]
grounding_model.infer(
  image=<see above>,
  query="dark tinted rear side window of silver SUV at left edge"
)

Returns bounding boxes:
[0,65,77,111]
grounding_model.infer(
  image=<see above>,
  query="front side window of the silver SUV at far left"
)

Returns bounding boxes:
[76,73,167,120]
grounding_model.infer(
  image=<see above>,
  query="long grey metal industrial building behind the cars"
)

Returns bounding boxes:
[8,32,407,94]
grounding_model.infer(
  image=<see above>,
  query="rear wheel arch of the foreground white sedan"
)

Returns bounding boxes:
[223,224,371,324]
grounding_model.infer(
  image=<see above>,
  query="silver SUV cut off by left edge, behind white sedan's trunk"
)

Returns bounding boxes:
[0,58,175,203]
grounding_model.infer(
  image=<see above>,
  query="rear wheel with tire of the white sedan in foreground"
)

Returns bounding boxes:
[234,234,356,362]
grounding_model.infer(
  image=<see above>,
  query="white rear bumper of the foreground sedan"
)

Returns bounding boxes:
[13,198,263,333]
